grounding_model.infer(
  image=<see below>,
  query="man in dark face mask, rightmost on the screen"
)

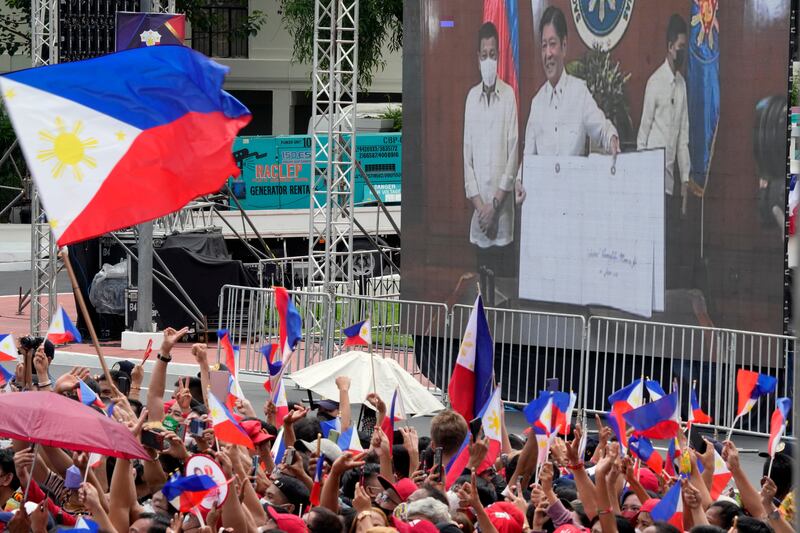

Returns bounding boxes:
[636,14,690,288]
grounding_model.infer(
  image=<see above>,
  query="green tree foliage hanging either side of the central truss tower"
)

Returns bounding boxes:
[280,0,403,91]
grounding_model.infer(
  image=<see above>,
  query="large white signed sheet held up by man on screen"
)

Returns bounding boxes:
[519,149,664,318]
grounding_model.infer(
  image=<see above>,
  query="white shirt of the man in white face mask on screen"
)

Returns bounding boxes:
[464,78,519,248]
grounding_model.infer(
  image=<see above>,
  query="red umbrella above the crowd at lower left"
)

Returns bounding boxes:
[0,392,150,459]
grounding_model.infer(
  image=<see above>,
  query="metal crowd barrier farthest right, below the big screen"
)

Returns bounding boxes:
[581,316,796,435]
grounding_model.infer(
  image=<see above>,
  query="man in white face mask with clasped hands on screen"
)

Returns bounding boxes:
[464,22,518,305]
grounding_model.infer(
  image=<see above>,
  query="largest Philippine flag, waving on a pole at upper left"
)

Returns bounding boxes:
[0,46,251,246]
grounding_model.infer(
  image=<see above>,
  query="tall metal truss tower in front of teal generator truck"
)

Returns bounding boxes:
[308,0,358,294]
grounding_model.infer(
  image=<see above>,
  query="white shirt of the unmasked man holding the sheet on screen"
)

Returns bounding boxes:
[524,71,617,155]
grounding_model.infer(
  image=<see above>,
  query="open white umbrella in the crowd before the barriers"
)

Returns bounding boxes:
[289,350,444,415]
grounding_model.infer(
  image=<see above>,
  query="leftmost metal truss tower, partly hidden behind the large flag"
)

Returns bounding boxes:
[30,0,58,335]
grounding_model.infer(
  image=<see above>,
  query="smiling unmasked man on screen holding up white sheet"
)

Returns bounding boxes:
[524,6,619,162]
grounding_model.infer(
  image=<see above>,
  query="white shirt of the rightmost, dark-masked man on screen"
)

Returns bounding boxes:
[636,60,690,195]
